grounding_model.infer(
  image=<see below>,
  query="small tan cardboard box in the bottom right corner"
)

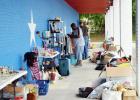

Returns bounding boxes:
[123,90,137,100]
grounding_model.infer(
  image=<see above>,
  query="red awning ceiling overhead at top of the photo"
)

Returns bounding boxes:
[65,0,112,14]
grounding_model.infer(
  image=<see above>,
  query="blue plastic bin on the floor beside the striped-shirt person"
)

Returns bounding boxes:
[37,80,49,95]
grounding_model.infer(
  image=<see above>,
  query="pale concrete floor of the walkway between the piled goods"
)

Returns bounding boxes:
[38,43,135,100]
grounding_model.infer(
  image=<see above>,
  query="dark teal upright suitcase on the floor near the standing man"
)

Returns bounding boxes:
[59,58,70,76]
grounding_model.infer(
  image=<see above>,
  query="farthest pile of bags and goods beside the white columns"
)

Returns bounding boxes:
[90,37,119,70]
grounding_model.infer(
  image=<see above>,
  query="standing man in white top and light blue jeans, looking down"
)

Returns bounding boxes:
[71,23,85,66]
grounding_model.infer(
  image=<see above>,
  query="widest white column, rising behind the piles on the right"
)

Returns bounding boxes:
[120,0,132,56]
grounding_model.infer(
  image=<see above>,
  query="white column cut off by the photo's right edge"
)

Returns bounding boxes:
[136,0,140,97]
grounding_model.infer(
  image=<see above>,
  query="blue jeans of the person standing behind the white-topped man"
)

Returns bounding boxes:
[83,36,89,59]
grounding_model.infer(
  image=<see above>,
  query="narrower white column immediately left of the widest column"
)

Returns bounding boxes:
[113,0,121,45]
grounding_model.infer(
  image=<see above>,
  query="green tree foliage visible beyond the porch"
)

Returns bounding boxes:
[80,0,136,33]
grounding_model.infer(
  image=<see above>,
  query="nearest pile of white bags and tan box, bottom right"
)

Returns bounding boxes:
[87,81,136,100]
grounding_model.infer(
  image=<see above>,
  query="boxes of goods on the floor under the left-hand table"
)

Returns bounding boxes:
[3,83,39,100]
